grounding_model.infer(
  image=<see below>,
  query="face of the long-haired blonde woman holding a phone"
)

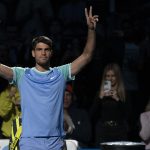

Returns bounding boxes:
[106,70,116,86]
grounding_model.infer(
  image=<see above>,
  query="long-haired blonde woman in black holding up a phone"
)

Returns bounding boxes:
[90,63,129,146]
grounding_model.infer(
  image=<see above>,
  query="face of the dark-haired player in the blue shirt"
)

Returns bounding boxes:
[32,42,52,66]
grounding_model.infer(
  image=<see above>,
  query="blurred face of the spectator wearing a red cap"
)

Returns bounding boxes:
[64,91,72,109]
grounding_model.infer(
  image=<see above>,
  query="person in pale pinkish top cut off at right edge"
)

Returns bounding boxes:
[139,101,150,150]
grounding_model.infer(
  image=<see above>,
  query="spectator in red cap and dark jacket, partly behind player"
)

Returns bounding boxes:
[64,85,91,147]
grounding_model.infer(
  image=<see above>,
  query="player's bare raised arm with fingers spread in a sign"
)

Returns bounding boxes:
[71,6,98,76]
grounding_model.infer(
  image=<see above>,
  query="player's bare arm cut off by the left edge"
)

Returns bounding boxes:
[0,64,13,81]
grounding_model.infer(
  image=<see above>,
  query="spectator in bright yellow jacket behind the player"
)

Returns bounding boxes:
[0,85,20,138]
